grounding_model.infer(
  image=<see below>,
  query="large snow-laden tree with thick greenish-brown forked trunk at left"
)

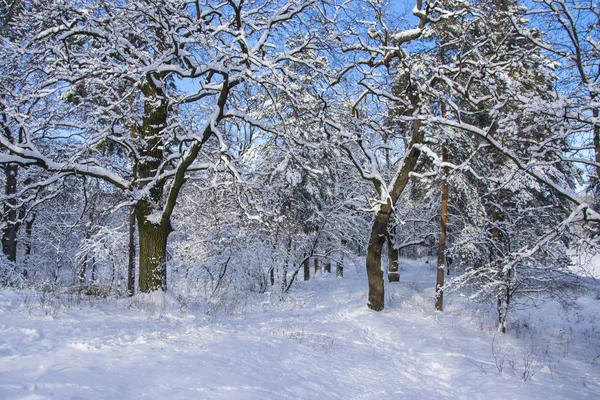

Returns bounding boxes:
[0,0,332,292]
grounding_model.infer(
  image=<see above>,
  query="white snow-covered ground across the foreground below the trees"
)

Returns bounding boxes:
[0,260,600,400]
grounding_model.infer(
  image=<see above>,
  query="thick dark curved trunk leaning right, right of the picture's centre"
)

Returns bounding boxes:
[366,120,423,311]
